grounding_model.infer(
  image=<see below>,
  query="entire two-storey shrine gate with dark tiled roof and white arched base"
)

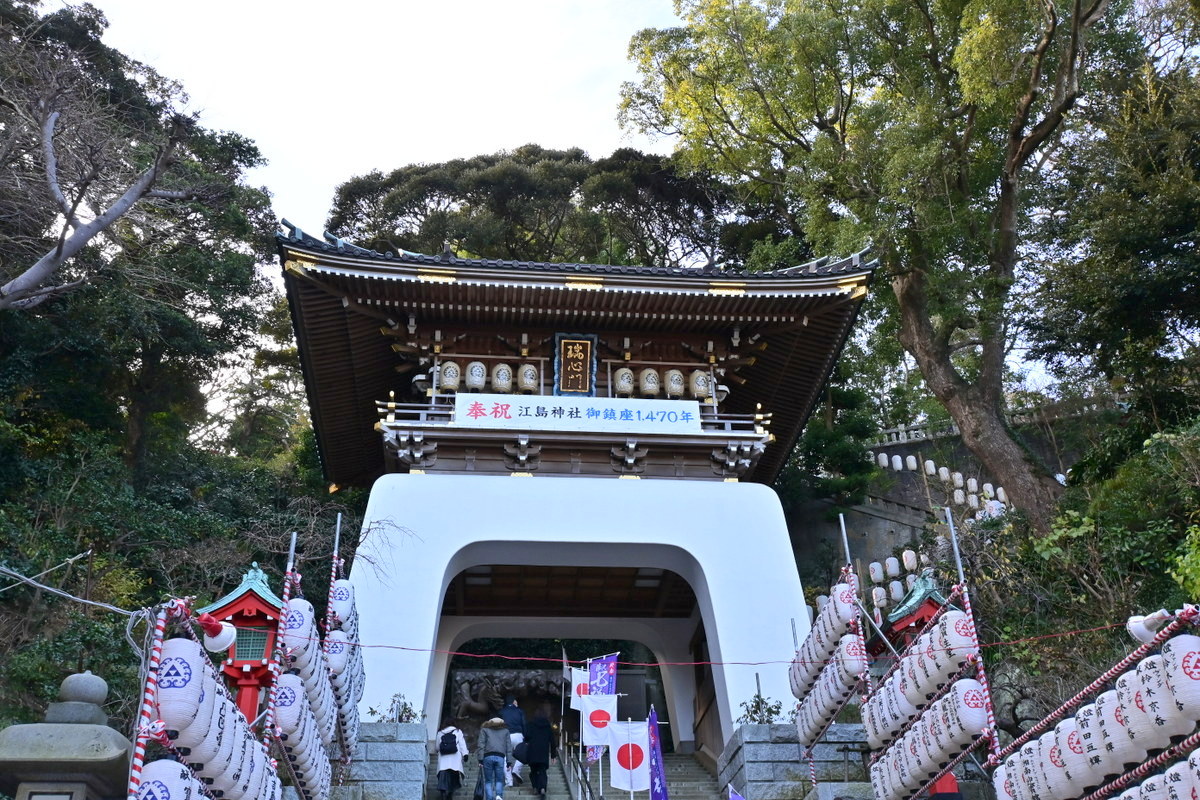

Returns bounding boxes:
[280,229,874,756]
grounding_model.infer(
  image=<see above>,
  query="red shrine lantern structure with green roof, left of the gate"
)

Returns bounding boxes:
[197,561,283,720]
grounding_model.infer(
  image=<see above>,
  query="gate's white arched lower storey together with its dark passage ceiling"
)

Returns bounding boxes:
[353,475,806,758]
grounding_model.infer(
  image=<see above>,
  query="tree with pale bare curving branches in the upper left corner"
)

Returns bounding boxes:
[0,2,266,311]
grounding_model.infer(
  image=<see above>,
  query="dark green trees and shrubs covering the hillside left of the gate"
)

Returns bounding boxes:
[0,4,362,726]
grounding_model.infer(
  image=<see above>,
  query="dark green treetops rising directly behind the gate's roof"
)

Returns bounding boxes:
[328,144,798,266]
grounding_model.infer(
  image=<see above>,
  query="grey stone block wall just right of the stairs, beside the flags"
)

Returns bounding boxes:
[716,724,866,800]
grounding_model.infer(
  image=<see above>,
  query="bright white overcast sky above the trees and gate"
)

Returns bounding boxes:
[83,0,678,234]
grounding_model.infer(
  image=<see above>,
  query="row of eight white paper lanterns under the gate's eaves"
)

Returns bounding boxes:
[438,361,713,401]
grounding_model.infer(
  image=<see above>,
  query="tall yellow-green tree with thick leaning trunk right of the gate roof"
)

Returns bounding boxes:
[622,0,1138,530]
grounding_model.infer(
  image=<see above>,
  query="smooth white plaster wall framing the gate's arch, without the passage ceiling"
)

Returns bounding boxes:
[350,474,808,739]
